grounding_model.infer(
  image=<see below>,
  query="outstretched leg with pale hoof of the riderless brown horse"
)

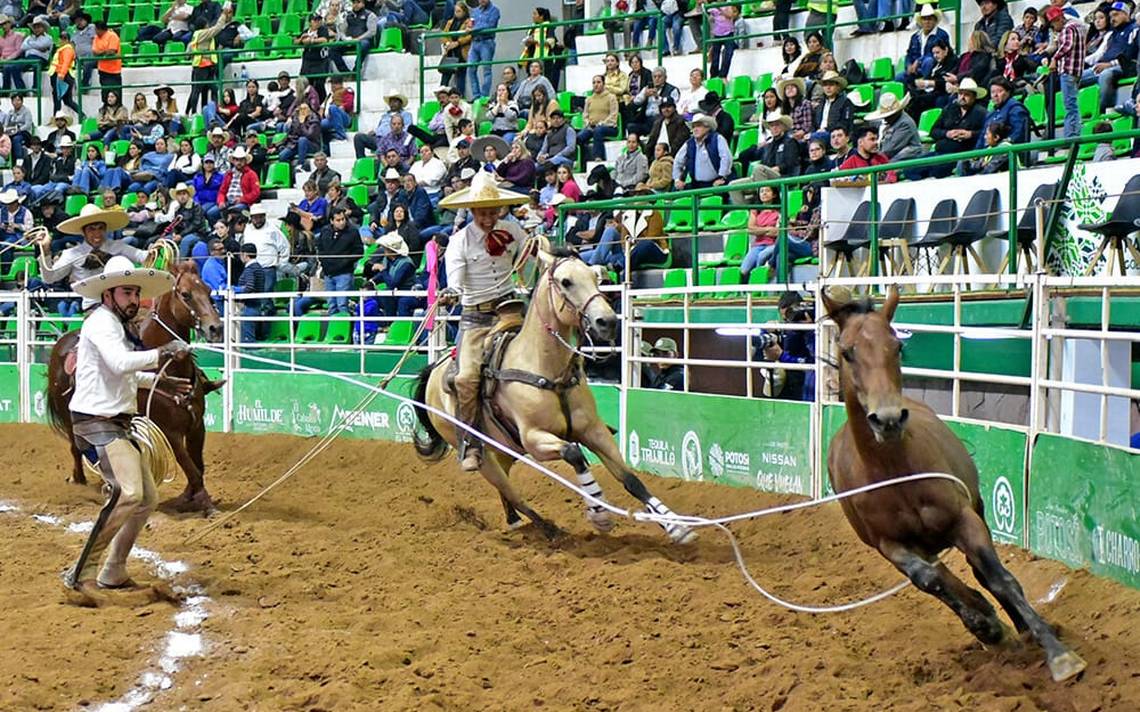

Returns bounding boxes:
[959,512,1086,682]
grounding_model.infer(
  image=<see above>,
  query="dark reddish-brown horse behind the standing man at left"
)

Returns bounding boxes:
[47,260,223,512]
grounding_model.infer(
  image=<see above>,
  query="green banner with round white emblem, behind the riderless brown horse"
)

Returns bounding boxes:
[823,406,1027,546]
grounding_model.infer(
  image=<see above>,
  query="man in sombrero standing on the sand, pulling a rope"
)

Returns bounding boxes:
[67,255,189,595]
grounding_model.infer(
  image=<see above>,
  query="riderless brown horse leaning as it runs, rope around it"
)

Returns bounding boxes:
[823,288,1085,681]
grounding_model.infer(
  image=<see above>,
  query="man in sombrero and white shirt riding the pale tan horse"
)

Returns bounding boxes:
[439,172,527,472]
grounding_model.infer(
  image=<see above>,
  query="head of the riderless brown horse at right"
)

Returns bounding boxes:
[823,287,910,442]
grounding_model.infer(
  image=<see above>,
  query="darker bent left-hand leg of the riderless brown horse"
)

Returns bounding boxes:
[879,541,1005,645]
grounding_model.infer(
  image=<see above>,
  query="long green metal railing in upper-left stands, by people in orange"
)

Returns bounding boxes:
[75,40,361,122]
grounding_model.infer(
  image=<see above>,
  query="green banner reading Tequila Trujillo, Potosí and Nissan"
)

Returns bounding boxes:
[626,388,812,496]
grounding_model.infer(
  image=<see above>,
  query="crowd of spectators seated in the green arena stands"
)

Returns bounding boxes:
[0,0,1138,341]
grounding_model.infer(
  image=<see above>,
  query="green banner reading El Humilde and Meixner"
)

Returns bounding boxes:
[234,371,416,442]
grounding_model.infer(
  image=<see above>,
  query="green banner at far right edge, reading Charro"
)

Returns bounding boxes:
[1029,434,1140,588]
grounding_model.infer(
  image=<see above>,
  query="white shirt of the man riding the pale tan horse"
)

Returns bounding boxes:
[443,220,527,306]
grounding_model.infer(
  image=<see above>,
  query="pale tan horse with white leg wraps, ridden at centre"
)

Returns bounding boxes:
[416,251,697,543]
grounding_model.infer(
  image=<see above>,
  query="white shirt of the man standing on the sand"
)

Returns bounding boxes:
[68,306,158,417]
